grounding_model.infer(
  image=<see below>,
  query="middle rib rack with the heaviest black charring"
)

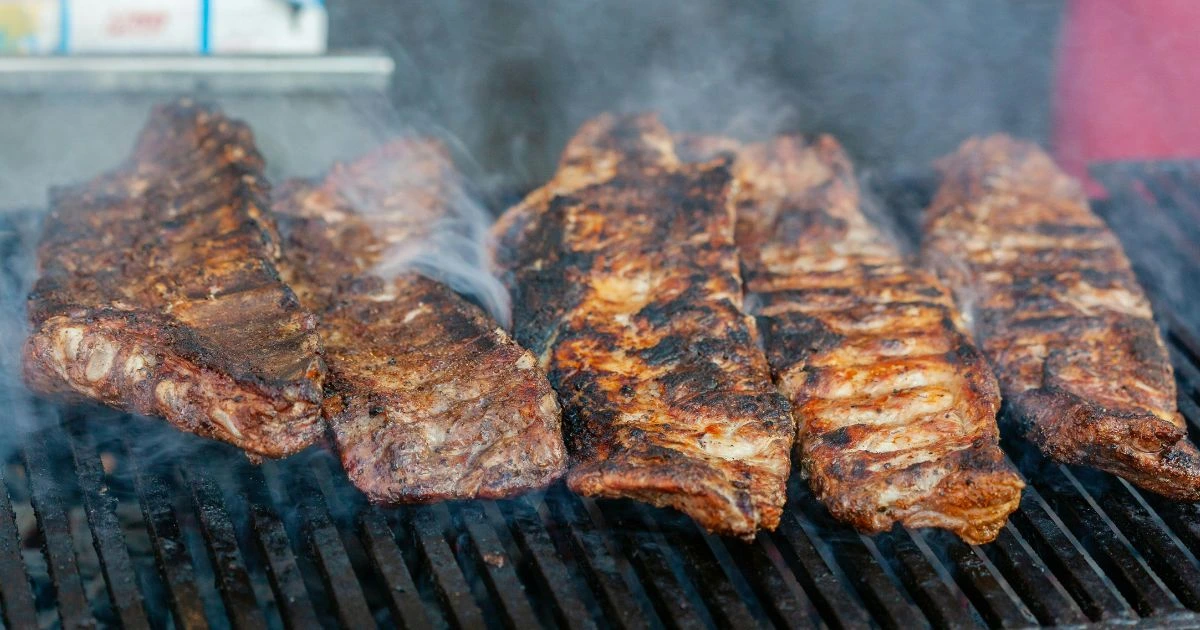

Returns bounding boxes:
[496,115,796,538]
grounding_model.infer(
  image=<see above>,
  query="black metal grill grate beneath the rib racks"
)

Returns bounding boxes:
[0,166,1200,629]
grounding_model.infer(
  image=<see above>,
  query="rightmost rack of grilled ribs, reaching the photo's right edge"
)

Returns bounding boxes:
[924,136,1200,500]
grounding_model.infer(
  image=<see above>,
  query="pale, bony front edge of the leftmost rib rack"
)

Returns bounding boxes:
[24,311,324,457]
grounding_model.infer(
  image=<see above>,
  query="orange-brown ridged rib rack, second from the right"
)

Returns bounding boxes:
[685,137,1025,544]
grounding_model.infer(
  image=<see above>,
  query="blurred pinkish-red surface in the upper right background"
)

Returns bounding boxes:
[1054,0,1200,194]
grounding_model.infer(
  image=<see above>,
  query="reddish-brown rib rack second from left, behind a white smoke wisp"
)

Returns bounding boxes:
[275,140,566,503]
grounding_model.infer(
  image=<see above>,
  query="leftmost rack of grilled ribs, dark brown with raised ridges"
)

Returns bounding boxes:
[24,101,324,457]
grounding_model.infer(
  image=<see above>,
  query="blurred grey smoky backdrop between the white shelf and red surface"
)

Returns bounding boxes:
[330,0,1061,193]
